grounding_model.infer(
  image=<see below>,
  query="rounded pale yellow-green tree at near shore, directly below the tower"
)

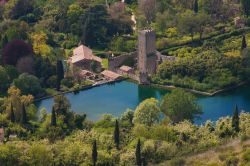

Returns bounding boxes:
[134,98,160,126]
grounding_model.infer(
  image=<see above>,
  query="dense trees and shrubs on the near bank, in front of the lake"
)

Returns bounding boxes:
[0,87,250,166]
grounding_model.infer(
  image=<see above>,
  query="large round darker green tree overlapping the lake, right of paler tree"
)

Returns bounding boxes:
[161,89,202,123]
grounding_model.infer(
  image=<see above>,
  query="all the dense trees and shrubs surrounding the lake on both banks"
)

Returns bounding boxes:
[0,0,250,166]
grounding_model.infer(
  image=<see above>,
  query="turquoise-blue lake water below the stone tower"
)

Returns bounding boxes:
[36,81,250,124]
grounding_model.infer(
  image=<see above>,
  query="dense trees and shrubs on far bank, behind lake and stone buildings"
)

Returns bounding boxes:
[0,0,250,94]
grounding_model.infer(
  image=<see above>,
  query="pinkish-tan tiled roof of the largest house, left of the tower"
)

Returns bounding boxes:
[71,45,102,63]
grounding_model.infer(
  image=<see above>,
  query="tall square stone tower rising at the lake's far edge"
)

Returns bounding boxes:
[138,30,158,84]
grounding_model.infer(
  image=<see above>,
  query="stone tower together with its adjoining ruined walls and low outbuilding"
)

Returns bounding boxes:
[108,30,164,84]
